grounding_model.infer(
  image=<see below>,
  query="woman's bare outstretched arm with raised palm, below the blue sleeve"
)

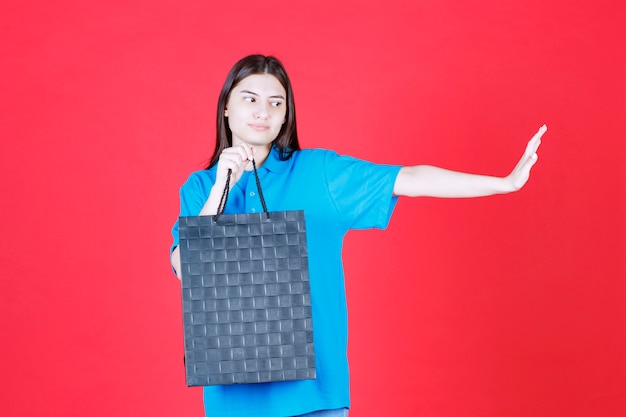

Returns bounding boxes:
[393,125,547,198]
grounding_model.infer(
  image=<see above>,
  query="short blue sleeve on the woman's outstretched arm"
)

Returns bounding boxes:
[324,151,401,229]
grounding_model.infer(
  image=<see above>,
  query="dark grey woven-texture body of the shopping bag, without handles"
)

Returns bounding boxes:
[179,210,315,386]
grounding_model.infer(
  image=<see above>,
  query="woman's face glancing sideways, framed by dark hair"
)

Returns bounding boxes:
[224,74,287,149]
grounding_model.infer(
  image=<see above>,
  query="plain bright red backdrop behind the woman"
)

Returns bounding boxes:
[0,0,626,417]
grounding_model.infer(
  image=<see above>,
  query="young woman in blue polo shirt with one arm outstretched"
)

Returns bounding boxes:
[171,55,546,417]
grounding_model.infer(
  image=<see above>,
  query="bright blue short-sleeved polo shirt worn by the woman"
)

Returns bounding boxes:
[172,148,400,417]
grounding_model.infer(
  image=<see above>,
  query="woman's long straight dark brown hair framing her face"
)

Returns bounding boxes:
[207,55,300,169]
